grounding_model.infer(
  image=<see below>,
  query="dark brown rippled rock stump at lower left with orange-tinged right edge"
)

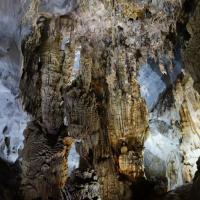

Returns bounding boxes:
[21,121,72,199]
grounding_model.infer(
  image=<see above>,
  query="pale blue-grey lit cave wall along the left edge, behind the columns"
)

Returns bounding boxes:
[0,0,28,162]
